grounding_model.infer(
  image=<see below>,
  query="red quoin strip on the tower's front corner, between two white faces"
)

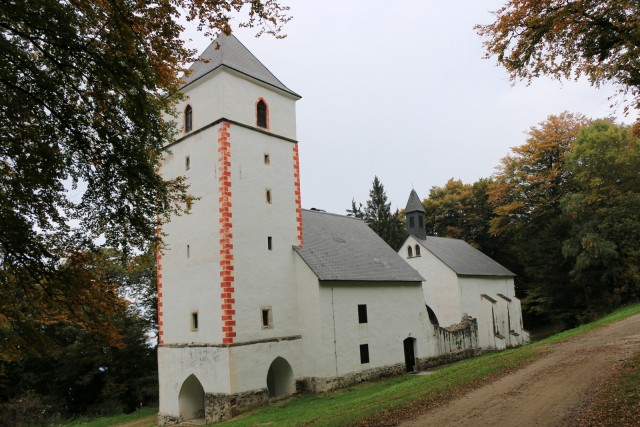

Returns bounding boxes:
[218,122,236,344]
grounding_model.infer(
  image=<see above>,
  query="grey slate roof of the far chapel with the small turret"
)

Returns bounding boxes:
[417,236,515,277]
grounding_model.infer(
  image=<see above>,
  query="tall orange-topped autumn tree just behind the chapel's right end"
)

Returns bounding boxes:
[489,113,587,322]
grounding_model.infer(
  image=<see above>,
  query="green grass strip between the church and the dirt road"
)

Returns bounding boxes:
[217,304,640,426]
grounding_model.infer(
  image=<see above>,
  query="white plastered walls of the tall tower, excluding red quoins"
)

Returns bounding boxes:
[158,61,302,416]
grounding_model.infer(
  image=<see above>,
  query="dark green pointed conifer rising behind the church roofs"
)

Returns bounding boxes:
[358,176,407,250]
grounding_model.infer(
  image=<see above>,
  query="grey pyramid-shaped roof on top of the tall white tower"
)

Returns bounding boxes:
[183,33,300,98]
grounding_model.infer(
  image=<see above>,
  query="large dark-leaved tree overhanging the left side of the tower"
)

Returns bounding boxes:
[0,0,289,354]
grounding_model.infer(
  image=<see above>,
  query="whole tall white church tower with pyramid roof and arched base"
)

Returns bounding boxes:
[158,35,303,424]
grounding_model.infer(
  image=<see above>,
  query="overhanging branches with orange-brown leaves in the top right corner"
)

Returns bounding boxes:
[476,0,640,108]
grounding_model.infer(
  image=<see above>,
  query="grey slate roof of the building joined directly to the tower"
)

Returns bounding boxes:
[295,210,424,282]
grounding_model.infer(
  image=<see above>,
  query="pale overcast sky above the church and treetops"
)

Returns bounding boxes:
[186,0,630,214]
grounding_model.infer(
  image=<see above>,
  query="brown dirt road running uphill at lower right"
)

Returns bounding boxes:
[402,316,640,427]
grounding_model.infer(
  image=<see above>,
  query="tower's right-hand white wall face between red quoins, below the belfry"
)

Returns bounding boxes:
[229,125,300,342]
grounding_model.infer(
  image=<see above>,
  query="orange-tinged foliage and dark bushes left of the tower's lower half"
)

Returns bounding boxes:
[0,249,158,425]
